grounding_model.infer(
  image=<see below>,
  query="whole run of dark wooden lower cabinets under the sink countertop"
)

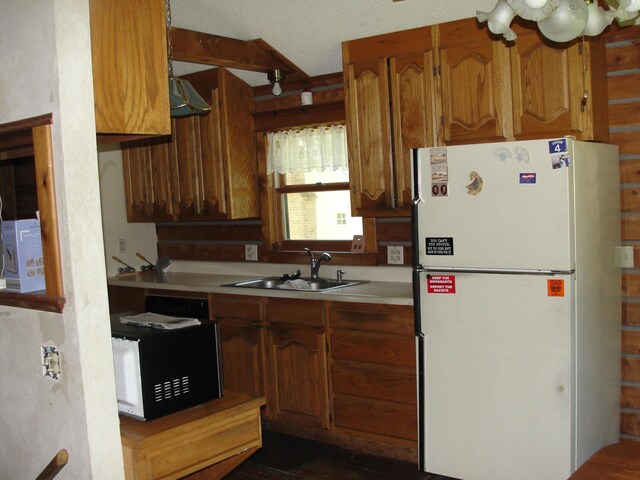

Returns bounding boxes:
[124,287,417,461]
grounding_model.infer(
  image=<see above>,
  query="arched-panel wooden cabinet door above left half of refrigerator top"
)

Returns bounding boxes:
[434,19,512,145]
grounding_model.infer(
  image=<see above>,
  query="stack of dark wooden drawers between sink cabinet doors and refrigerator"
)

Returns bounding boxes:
[329,302,417,460]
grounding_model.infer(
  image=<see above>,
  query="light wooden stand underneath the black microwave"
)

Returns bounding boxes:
[120,391,265,480]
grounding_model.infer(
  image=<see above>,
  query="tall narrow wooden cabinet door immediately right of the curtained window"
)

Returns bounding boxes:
[345,59,393,215]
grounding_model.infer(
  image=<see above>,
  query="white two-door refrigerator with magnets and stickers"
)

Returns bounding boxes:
[412,137,620,480]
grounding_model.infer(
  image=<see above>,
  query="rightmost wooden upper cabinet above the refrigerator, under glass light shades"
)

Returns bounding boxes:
[509,29,608,141]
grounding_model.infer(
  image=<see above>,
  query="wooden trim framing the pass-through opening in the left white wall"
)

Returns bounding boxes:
[0,114,65,313]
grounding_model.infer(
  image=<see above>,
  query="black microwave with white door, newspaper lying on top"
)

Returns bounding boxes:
[111,297,223,420]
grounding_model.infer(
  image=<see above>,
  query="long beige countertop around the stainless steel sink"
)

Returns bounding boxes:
[107,272,413,305]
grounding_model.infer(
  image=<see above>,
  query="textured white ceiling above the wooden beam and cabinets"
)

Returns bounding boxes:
[171,0,496,85]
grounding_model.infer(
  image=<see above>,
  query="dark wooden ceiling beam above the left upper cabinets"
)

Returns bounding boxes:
[170,27,308,77]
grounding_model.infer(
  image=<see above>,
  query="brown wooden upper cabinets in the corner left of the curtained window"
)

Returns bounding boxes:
[123,68,260,222]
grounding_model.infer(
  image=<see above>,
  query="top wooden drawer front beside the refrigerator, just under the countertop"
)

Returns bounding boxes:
[330,302,414,335]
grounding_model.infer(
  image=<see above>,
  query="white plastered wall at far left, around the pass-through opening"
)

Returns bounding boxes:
[0,0,123,480]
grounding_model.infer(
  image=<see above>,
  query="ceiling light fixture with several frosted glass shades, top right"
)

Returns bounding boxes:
[476,0,640,43]
